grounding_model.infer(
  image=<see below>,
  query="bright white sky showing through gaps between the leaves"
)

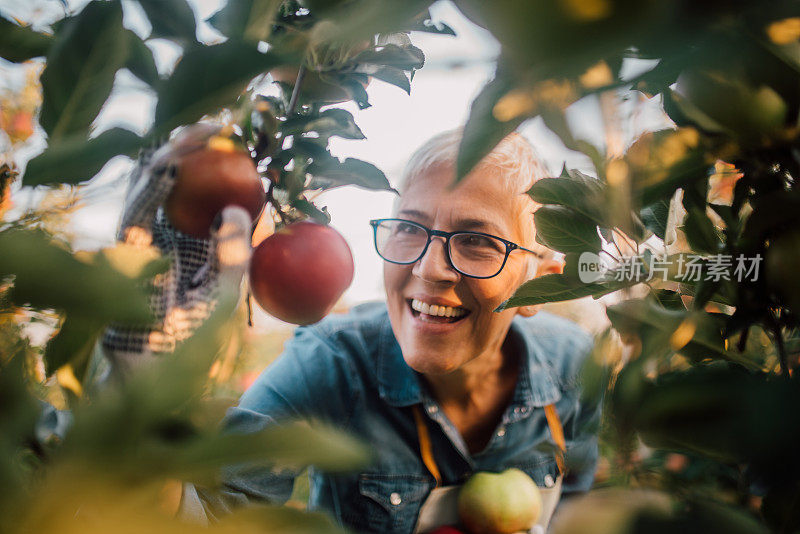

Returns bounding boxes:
[0,0,662,327]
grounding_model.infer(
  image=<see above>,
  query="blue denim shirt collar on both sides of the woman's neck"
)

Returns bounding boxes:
[377,314,561,408]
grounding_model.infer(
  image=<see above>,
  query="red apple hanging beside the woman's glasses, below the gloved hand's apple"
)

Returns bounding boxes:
[250,221,353,325]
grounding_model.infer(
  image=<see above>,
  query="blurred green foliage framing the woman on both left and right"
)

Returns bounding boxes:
[0,0,800,533]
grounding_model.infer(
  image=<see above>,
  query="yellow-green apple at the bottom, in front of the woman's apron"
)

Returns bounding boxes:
[458,468,542,534]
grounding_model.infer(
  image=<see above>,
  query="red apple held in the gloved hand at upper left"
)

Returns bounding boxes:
[165,142,266,238]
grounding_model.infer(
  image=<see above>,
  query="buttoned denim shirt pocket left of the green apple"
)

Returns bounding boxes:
[347,473,430,533]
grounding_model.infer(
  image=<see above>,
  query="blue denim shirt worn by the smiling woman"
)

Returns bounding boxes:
[216,304,599,533]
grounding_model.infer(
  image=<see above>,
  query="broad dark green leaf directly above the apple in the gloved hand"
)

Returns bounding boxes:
[156,40,281,133]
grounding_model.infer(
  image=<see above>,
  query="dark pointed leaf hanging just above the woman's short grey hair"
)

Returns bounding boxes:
[456,75,526,182]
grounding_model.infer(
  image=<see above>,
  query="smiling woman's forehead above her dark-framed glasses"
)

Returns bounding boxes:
[397,166,533,238]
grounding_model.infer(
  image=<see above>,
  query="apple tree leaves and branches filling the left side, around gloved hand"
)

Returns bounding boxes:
[0,0,453,533]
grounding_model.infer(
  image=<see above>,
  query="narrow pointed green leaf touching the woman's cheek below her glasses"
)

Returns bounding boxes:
[495,274,634,311]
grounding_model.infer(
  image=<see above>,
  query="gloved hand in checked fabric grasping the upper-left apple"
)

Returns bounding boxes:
[102,124,251,376]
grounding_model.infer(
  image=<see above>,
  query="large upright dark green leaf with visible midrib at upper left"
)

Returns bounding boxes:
[39,2,129,142]
